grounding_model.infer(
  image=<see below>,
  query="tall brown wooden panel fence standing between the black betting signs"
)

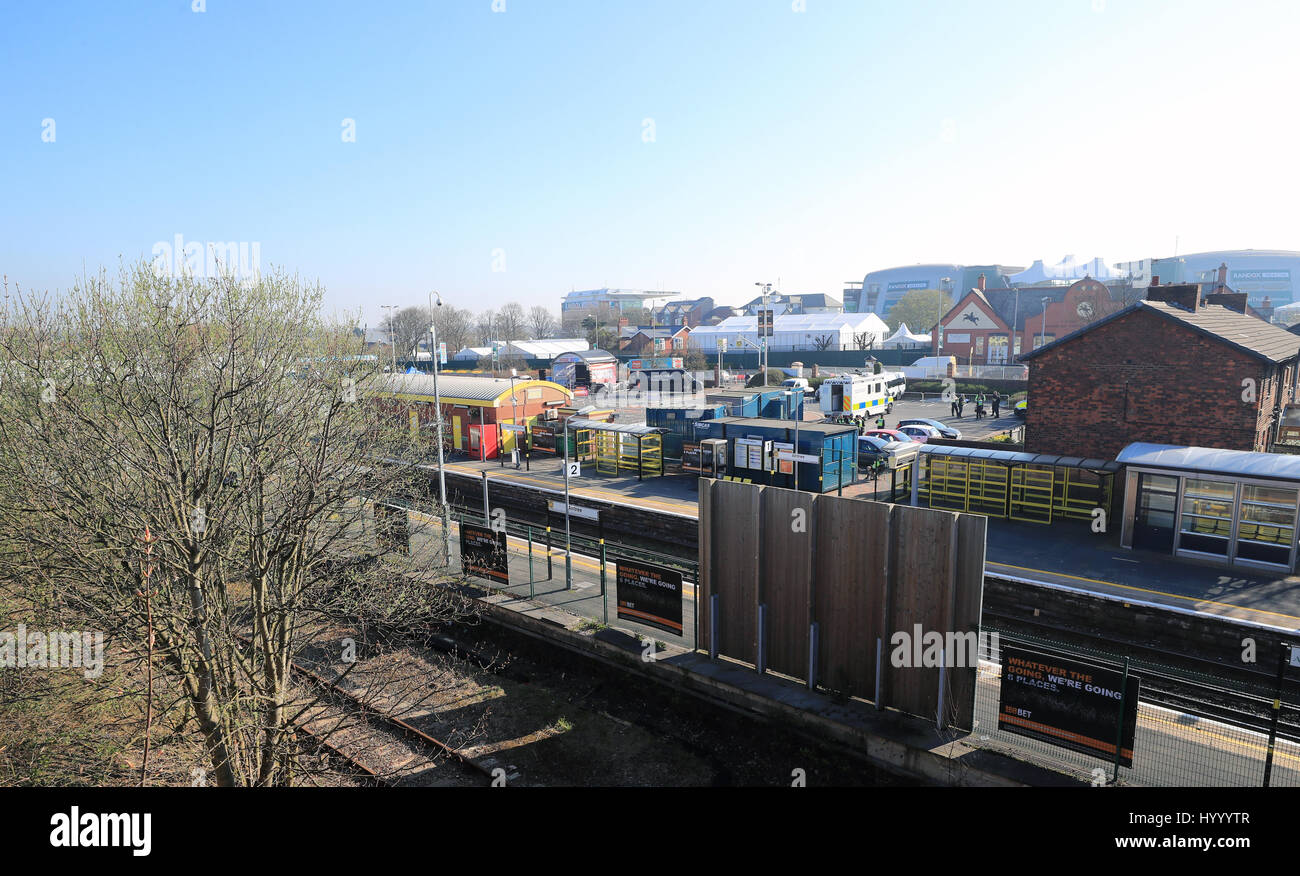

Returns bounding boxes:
[697,480,987,729]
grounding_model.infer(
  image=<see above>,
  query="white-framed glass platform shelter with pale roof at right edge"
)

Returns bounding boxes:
[1117,443,1300,572]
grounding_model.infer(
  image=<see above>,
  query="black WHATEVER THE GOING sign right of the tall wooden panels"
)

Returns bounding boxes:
[997,646,1140,767]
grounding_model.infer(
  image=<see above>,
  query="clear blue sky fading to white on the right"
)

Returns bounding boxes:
[0,0,1300,324]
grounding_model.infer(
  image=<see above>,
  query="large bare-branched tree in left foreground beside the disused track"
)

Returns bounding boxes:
[0,265,473,786]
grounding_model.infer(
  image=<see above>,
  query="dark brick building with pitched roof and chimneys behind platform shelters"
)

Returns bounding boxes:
[1021,285,1300,459]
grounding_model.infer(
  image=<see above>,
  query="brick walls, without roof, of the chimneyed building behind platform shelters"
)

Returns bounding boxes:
[1024,311,1292,459]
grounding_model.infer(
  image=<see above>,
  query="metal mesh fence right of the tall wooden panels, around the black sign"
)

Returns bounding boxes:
[965,626,1300,788]
